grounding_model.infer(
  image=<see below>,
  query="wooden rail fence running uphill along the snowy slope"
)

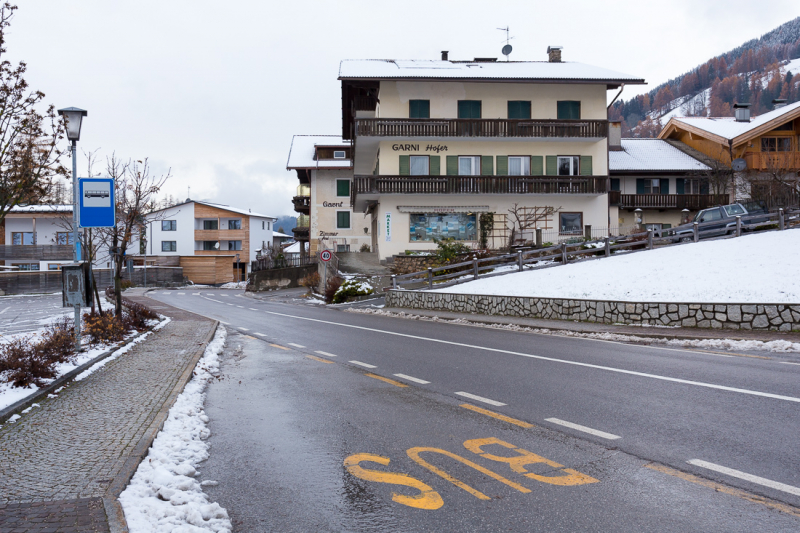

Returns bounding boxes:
[384,209,800,291]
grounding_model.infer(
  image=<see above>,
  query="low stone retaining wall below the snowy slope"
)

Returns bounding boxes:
[386,290,800,331]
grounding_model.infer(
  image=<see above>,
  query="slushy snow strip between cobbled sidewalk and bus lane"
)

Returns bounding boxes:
[119,325,232,533]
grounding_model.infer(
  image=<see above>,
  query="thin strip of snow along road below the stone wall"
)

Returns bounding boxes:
[345,307,800,353]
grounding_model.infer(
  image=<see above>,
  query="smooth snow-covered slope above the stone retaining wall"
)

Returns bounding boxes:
[434,229,800,304]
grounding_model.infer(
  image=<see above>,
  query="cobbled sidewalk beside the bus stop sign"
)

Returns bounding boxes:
[0,291,216,533]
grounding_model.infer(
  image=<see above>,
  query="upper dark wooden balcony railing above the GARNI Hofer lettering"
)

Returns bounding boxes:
[355,118,608,138]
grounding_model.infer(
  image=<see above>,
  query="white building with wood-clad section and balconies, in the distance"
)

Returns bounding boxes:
[138,199,276,284]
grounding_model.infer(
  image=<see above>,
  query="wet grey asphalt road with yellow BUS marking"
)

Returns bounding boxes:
[149,290,800,531]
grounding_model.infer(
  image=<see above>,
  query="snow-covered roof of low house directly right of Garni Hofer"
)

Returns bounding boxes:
[608,139,710,171]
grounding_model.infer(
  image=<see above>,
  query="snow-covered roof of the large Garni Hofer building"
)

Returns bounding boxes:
[339,59,644,83]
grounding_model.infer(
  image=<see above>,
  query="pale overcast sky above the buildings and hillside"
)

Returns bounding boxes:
[7,0,800,216]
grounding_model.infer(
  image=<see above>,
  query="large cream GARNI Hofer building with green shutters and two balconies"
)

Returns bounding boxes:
[339,47,644,259]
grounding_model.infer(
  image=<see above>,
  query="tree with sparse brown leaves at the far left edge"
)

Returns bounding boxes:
[0,2,67,221]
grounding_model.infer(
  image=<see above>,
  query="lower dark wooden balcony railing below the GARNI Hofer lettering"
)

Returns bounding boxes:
[351,176,608,198]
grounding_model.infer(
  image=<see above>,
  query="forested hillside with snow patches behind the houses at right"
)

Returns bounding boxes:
[609,17,800,137]
